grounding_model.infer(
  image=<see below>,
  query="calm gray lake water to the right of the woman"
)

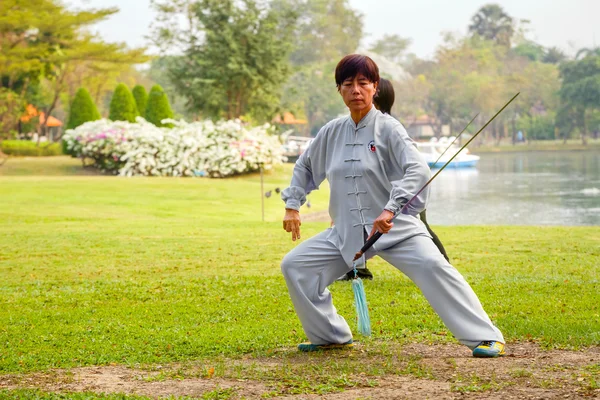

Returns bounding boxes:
[427,149,600,225]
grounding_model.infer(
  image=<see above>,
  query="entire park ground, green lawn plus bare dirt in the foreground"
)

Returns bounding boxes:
[0,157,600,399]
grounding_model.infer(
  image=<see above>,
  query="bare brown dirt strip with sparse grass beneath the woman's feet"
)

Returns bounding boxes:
[0,343,600,400]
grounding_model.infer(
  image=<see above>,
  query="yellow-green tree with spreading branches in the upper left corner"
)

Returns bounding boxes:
[0,0,148,141]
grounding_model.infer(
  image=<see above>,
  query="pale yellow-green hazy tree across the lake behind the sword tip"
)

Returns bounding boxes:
[393,35,560,142]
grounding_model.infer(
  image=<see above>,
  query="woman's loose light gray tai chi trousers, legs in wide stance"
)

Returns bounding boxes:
[281,231,504,349]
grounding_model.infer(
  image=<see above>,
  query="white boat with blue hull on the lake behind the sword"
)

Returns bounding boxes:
[417,136,480,169]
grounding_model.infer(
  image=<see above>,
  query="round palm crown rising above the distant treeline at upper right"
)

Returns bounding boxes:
[469,4,515,46]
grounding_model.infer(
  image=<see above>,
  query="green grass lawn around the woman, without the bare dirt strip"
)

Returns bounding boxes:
[0,157,600,376]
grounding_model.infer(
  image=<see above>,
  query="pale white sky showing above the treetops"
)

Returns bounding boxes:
[71,0,600,58]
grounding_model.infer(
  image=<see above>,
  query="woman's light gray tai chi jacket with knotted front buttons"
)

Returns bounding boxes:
[281,106,431,267]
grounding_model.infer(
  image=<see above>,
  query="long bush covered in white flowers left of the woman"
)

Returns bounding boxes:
[63,118,285,178]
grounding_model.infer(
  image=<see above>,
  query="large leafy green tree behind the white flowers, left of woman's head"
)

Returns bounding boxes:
[157,0,295,121]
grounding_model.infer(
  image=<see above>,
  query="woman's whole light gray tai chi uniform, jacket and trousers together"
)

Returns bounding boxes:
[281,107,504,348]
